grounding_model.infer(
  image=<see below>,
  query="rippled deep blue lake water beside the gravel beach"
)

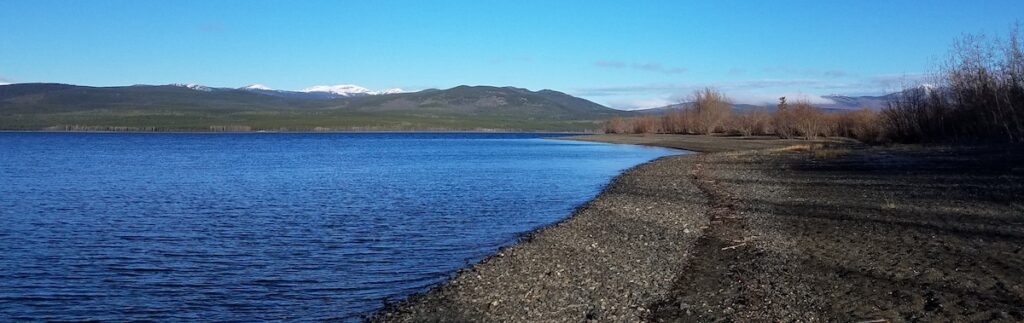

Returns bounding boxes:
[0,133,677,321]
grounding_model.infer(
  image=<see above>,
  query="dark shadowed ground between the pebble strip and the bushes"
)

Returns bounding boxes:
[650,148,1024,322]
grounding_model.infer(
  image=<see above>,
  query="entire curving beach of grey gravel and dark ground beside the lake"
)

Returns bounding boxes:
[368,134,1024,322]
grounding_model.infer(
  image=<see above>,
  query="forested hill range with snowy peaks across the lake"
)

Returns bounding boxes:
[0,83,635,131]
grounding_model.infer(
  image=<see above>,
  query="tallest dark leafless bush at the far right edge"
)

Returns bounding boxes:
[883,28,1024,144]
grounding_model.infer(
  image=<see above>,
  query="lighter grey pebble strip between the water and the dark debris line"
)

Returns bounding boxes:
[370,133,785,322]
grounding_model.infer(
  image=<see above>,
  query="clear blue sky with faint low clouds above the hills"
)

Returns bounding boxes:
[0,0,1024,109]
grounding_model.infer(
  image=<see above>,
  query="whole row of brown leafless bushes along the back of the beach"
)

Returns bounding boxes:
[604,28,1024,144]
